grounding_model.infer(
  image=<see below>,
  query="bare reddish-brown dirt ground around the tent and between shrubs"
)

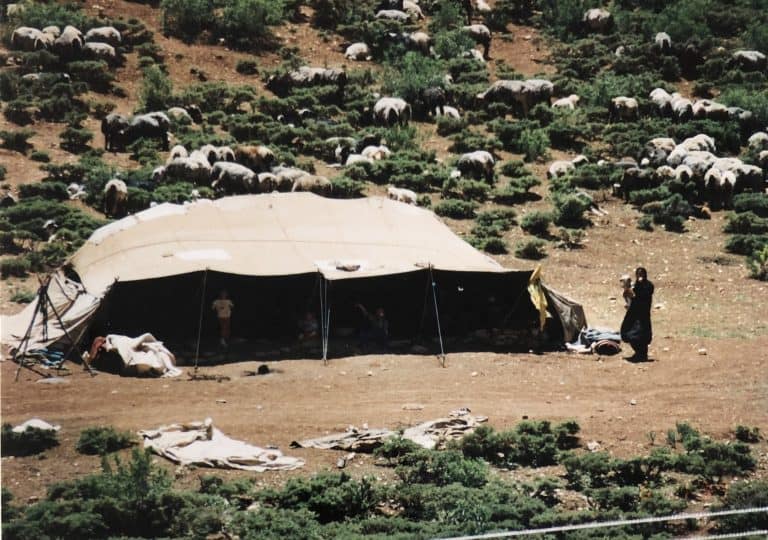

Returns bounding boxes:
[0,0,768,508]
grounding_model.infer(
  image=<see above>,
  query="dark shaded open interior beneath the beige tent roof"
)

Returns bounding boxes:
[91,269,557,356]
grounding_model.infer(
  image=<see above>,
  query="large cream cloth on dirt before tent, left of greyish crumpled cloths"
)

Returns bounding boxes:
[139,418,304,472]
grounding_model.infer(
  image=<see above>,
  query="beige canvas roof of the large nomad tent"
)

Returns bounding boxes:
[71,193,509,294]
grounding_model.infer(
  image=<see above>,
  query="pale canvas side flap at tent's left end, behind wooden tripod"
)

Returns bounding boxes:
[0,272,102,351]
